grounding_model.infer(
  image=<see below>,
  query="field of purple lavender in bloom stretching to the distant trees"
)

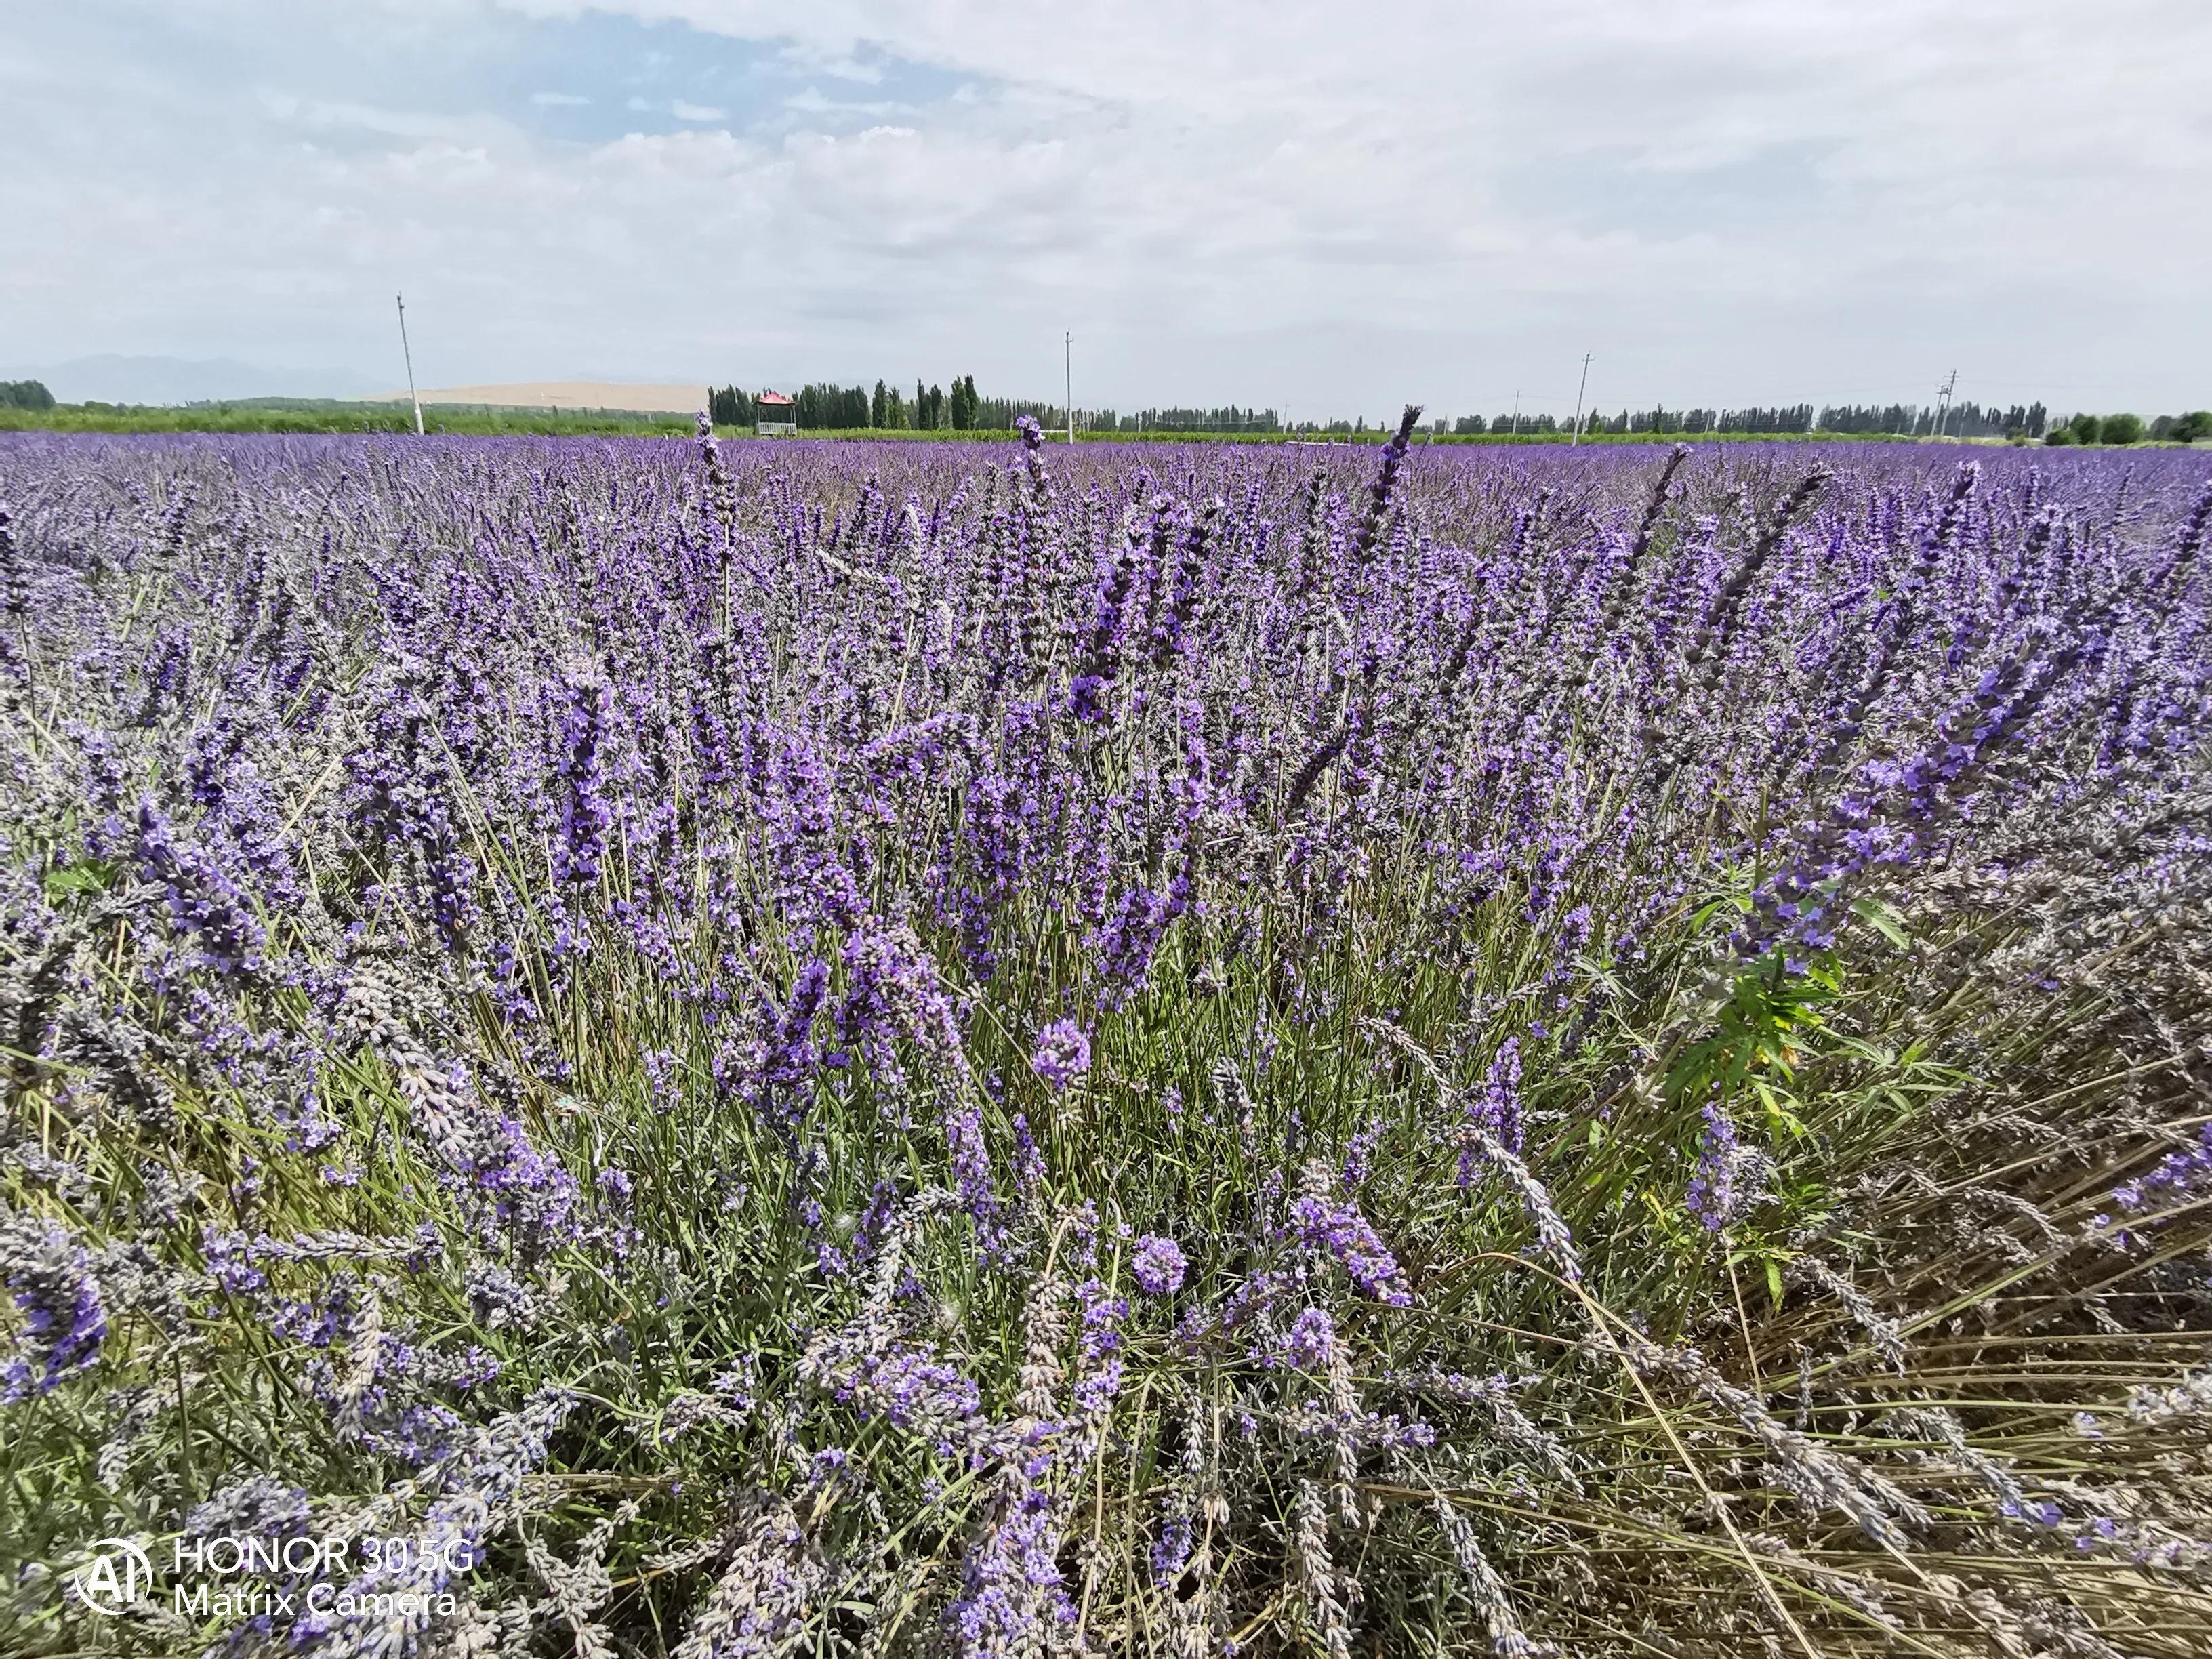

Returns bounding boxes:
[0,416,2212,1659]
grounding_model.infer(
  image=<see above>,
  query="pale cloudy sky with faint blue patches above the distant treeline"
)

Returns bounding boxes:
[0,0,2212,420]
